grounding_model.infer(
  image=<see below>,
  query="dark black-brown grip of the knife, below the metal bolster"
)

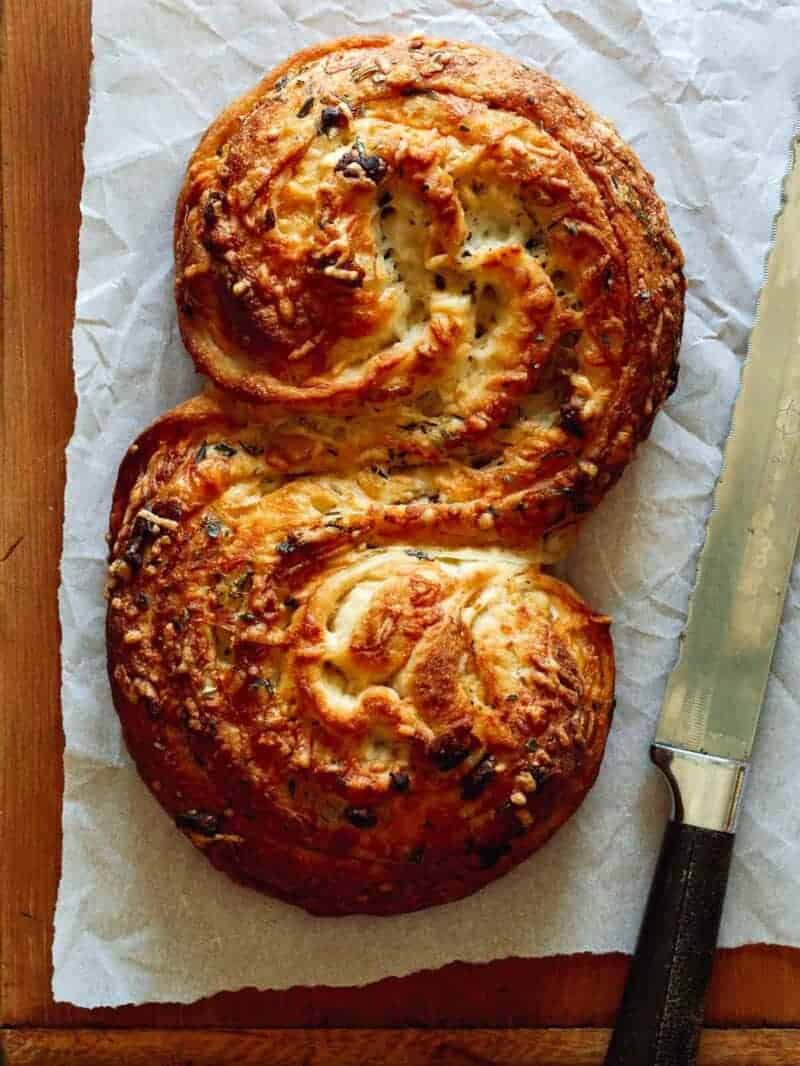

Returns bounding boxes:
[606,822,734,1066]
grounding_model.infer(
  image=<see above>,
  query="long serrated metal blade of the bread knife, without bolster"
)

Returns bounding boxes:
[656,133,800,762]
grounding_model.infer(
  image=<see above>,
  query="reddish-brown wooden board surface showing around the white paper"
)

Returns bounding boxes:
[0,0,800,1066]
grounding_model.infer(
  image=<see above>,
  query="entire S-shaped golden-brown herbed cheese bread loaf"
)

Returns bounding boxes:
[108,38,684,914]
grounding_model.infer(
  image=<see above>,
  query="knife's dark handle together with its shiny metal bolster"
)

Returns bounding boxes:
[605,748,746,1066]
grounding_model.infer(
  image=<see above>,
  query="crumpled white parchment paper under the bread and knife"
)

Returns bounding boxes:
[53,0,800,1006]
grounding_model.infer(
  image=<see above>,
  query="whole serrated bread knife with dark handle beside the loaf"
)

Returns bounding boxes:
[606,136,800,1066]
